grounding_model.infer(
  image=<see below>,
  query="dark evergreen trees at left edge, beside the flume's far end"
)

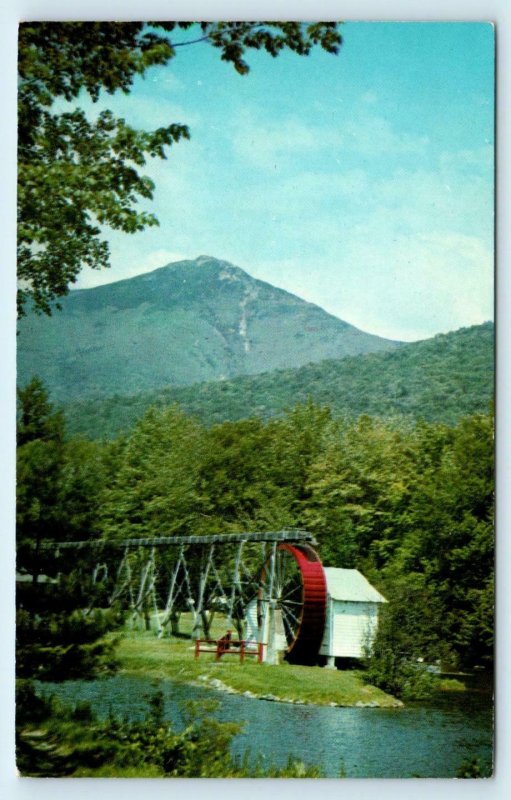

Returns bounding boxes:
[16,378,120,692]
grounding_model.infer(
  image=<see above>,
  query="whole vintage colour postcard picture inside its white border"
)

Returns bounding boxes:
[16,20,495,779]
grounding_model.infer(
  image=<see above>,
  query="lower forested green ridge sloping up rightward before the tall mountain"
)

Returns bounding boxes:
[66,322,494,438]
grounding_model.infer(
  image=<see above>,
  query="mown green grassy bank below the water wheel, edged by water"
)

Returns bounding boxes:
[117,630,402,708]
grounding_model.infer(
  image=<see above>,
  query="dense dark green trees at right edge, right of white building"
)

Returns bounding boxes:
[399,415,494,662]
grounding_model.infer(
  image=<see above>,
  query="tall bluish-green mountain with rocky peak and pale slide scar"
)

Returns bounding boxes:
[18,256,399,402]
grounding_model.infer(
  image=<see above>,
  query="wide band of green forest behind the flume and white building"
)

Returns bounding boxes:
[18,384,493,676]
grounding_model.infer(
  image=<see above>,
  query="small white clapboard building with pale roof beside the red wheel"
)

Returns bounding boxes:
[319,567,387,667]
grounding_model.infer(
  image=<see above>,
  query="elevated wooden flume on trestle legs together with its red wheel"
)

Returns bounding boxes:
[38,529,326,663]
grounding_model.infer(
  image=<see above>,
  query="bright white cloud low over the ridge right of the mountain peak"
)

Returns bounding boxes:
[242,221,493,341]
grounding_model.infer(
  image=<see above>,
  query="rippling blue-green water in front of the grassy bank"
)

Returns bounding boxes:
[34,675,493,778]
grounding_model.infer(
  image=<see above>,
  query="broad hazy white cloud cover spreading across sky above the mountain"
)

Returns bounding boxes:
[67,83,493,340]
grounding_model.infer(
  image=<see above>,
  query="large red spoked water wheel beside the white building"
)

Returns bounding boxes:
[258,543,326,664]
